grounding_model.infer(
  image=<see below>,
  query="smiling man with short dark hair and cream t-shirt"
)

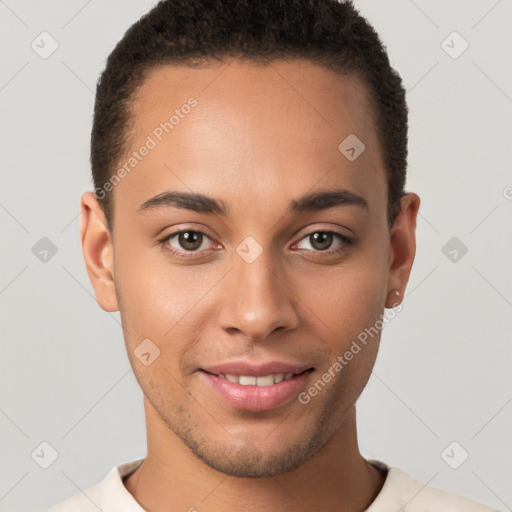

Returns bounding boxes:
[50,0,491,512]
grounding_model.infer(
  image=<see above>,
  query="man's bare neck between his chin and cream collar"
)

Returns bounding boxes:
[124,398,385,512]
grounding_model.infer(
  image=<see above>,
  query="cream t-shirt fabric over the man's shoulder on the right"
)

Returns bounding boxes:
[367,467,499,512]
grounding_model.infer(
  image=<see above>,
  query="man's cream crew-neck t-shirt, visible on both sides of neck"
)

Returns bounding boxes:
[46,459,499,512]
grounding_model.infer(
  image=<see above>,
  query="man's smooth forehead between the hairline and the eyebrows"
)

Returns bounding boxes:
[114,60,386,222]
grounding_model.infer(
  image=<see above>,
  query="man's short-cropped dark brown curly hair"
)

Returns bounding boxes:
[91,0,408,232]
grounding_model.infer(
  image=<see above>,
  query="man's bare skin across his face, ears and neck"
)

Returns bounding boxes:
[81,60,420,512]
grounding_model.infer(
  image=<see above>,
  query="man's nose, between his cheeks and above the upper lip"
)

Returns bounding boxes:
[218,246,299,341]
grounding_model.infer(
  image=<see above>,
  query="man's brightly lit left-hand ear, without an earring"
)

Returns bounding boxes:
[80,192,119,312]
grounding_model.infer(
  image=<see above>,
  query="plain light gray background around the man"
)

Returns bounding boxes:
[0,0,512,511]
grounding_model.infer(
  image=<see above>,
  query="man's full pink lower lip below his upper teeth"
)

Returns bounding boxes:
[200,370,312,411]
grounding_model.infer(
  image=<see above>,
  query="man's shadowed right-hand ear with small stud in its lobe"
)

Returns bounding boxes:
[386,192,420,308]
